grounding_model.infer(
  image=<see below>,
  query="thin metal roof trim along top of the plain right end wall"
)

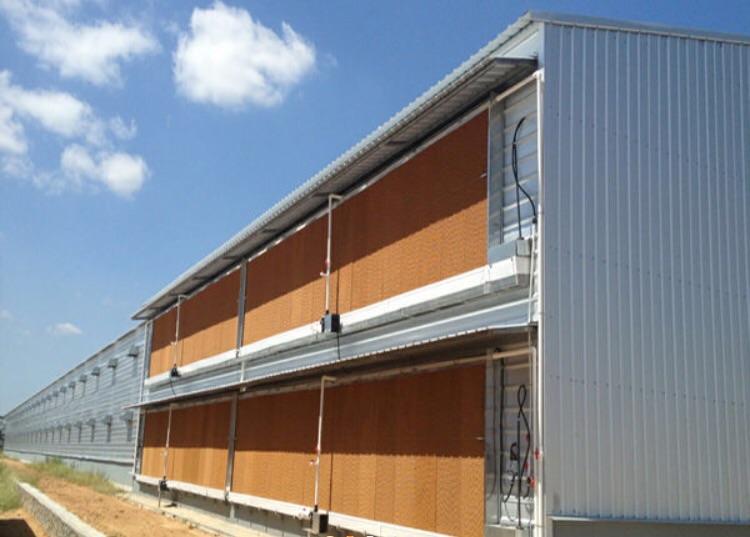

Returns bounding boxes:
[526,10,750,45]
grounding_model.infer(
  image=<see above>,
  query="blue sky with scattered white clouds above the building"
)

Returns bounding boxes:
[0,0,750,414]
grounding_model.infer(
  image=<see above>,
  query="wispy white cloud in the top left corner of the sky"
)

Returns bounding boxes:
[0,0,159,85]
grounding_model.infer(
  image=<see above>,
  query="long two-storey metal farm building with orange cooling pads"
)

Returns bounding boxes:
[6,12,750,537]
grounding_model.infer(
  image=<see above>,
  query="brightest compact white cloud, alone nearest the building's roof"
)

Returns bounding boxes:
[174,2,315,108]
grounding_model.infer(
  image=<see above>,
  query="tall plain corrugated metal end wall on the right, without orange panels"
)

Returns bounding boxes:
[543,24,750,521]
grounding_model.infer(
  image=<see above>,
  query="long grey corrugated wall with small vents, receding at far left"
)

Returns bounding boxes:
[5,325,146,478]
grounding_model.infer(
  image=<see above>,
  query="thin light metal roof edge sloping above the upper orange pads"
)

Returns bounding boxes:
[132,13,532,319]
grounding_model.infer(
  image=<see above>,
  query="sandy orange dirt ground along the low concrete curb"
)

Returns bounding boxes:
[0,459,217,537]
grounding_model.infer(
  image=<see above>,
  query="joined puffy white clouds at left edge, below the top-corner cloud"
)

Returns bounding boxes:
[0,71,149,198]
